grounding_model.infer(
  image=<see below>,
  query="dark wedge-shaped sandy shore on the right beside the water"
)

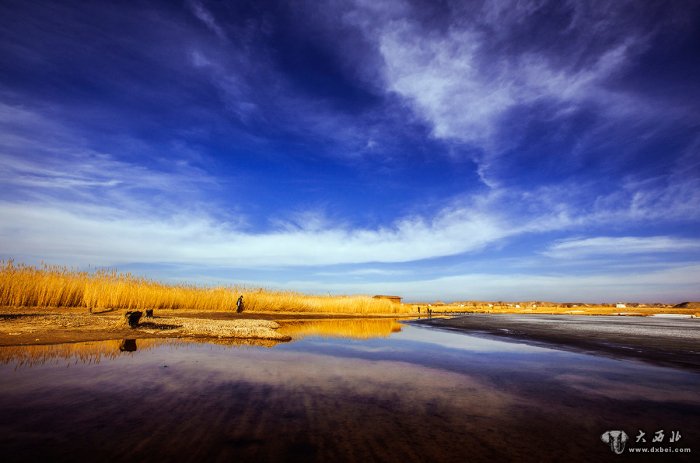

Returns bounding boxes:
[413,314,700,370]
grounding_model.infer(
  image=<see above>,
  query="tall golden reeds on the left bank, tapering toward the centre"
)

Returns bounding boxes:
[0,260,411,314]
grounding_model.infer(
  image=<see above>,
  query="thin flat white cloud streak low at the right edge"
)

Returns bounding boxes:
[544,236,700,259]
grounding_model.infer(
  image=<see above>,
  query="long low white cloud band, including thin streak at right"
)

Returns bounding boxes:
[0,179,700,276]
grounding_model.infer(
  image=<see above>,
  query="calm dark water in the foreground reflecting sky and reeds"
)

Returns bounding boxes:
[0,320,700,462]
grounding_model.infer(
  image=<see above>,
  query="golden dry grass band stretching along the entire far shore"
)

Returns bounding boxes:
[0,260,700,316]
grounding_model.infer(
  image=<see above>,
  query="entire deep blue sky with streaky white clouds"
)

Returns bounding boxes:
[0,0,700,302]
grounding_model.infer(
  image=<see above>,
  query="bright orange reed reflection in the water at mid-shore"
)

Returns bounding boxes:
[279,319,401,339]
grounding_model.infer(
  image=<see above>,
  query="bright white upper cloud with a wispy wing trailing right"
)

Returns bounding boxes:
[375,4,641,149]
